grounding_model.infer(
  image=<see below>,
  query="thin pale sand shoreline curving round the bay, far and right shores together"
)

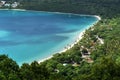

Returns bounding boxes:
[0,9,101,63]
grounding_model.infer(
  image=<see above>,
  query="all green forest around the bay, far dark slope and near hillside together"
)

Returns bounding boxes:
[0,0,120,80]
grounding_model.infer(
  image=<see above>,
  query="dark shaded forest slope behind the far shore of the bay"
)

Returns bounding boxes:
[0,0,120,18]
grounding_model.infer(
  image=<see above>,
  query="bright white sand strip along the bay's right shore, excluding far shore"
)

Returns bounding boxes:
[38,15,101,63]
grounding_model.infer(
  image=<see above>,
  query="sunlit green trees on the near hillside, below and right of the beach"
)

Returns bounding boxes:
[0,17,120,80]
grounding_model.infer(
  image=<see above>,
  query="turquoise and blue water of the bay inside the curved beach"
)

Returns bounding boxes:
[0,10,98,65]
